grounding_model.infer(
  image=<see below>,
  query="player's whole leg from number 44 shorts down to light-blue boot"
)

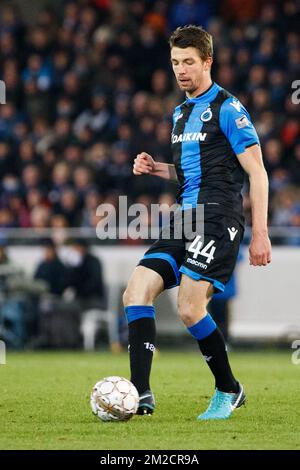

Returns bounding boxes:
[179,207,245,419]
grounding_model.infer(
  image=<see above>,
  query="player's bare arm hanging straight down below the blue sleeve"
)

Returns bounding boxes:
[237,144,271,266]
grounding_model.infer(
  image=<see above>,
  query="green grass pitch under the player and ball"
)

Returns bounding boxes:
[0,350,300,450]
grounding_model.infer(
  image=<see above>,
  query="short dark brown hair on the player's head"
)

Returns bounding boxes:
[169,25,213,60]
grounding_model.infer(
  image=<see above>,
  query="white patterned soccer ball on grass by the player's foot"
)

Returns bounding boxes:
[90,376,139,421]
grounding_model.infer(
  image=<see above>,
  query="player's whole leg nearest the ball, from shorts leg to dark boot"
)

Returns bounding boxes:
[124,207,185,414]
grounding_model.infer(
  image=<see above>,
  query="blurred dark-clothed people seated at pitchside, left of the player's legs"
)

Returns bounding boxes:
[0,239,106,349]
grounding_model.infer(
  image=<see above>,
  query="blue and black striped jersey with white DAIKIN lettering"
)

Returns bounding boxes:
[172,83,259,213]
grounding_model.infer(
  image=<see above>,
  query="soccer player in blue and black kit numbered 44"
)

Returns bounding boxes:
[124,25,271,420]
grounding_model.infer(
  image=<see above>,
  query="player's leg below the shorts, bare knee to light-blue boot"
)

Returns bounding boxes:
[178,275,245,420]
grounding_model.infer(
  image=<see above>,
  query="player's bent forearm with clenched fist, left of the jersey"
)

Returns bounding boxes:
[133,152,177,182]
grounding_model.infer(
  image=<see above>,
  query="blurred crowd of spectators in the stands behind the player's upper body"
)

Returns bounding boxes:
[0,0,300,241]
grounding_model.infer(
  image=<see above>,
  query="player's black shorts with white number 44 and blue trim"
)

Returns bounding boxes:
[139,205,244,292]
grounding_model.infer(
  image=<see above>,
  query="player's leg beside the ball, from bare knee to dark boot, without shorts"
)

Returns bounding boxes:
[123,266,164,412]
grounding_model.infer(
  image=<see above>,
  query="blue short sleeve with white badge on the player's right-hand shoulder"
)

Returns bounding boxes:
[220,97,260,155]
